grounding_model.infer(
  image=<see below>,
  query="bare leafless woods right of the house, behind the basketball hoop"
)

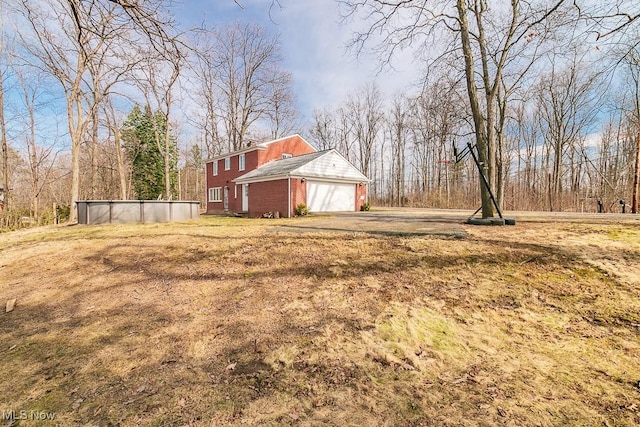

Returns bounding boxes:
[309,61,640,212]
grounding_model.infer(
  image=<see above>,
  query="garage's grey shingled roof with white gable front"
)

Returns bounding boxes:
[233,149,369,184]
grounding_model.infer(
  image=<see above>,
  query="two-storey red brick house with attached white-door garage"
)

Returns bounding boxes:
[206,135,369,217]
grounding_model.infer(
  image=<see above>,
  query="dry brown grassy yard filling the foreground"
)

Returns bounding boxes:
[0,212,640,426]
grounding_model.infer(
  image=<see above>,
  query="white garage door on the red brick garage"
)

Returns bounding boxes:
[307,181,356,212]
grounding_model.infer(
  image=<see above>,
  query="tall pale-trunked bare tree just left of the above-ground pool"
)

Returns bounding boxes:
[20,0,175,222]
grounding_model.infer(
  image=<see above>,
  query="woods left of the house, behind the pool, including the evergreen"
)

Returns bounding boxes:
[0,0,299,227]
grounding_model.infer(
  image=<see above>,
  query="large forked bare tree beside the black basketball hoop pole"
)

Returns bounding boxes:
[340,0,564,218]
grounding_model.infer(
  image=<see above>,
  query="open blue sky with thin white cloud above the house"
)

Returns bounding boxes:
[173,0,417,120]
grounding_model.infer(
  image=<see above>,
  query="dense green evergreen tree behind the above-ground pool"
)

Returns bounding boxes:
[122,105,178,200]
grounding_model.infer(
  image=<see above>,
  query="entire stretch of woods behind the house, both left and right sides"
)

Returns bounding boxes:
[0,0,640,228]
